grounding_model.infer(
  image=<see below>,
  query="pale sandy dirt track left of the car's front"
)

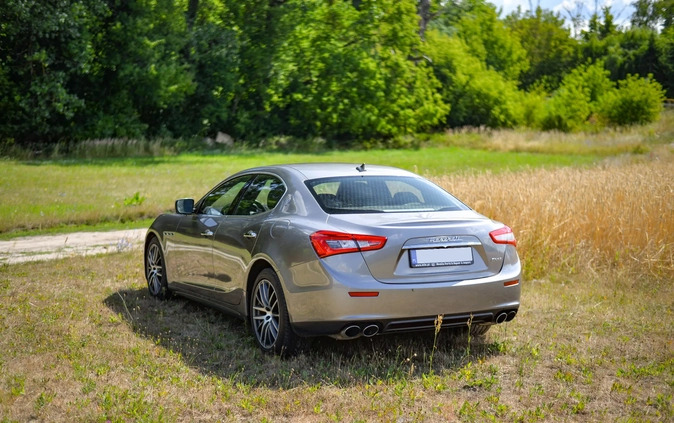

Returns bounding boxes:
[0,229,147,264]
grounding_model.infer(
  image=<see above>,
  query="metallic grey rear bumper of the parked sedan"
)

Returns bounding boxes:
[285,252,521,338]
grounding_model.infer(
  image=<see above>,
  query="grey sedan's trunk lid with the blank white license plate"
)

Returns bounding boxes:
[328,210,505,284]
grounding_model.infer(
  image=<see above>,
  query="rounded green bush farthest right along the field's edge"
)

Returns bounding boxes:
[600,75,664,126]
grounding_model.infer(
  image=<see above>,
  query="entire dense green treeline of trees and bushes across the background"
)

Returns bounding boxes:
[0,0,674,150]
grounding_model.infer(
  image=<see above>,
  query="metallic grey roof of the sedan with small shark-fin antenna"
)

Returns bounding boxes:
[239,163,418,180]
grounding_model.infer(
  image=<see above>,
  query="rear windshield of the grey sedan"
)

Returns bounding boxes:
[306,176,468,214]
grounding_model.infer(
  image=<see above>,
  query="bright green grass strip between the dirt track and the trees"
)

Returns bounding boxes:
[0,147,600,237]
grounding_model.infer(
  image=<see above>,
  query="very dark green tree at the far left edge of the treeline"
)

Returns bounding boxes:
[0,0,107,145]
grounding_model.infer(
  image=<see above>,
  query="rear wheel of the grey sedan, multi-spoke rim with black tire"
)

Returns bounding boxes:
[248,269,298,356]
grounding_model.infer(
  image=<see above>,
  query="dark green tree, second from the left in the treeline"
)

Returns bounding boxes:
[81,0,195,138]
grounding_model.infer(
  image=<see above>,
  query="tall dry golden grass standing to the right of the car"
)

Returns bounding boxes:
[435,151,674,278]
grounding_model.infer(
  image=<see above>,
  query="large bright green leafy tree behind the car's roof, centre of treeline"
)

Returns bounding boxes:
[267,0,447,139]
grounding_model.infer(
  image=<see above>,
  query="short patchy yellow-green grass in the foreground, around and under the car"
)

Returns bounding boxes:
[0,251,674,422]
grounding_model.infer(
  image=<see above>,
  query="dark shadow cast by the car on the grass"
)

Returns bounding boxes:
[104,288,503,389]
